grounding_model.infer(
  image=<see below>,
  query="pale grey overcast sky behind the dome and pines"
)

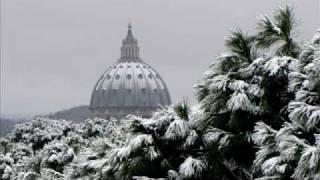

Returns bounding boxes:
[1,0,320,115]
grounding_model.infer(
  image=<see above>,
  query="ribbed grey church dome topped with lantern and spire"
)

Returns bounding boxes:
[90,25,171,117]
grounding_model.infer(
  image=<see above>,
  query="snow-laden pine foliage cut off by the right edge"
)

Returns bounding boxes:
[254,31,320,180]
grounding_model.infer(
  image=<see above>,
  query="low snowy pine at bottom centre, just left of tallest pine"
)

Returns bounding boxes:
[86,103,209,179]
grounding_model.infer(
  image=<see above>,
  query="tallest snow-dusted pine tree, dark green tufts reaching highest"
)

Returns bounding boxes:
[196,7,299,179]
